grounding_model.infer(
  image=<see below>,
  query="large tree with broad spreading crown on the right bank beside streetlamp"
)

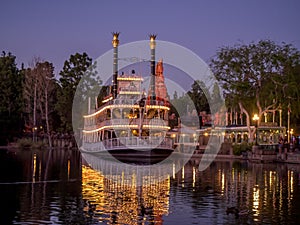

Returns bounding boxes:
[211,40,300,140]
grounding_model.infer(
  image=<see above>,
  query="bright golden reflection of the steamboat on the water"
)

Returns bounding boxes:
[82,153,188,224]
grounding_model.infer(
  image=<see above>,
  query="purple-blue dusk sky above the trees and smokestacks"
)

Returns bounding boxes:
[0,0,300,76]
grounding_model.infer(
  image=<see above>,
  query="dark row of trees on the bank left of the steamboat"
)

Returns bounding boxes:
[0,52,101,146]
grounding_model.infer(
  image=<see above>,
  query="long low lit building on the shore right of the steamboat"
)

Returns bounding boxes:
[170,107,287,152]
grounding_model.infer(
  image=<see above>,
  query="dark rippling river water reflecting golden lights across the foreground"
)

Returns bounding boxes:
[0,150,300,225]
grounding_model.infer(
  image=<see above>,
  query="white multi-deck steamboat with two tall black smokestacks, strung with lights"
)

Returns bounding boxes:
[80,33,174,159]
